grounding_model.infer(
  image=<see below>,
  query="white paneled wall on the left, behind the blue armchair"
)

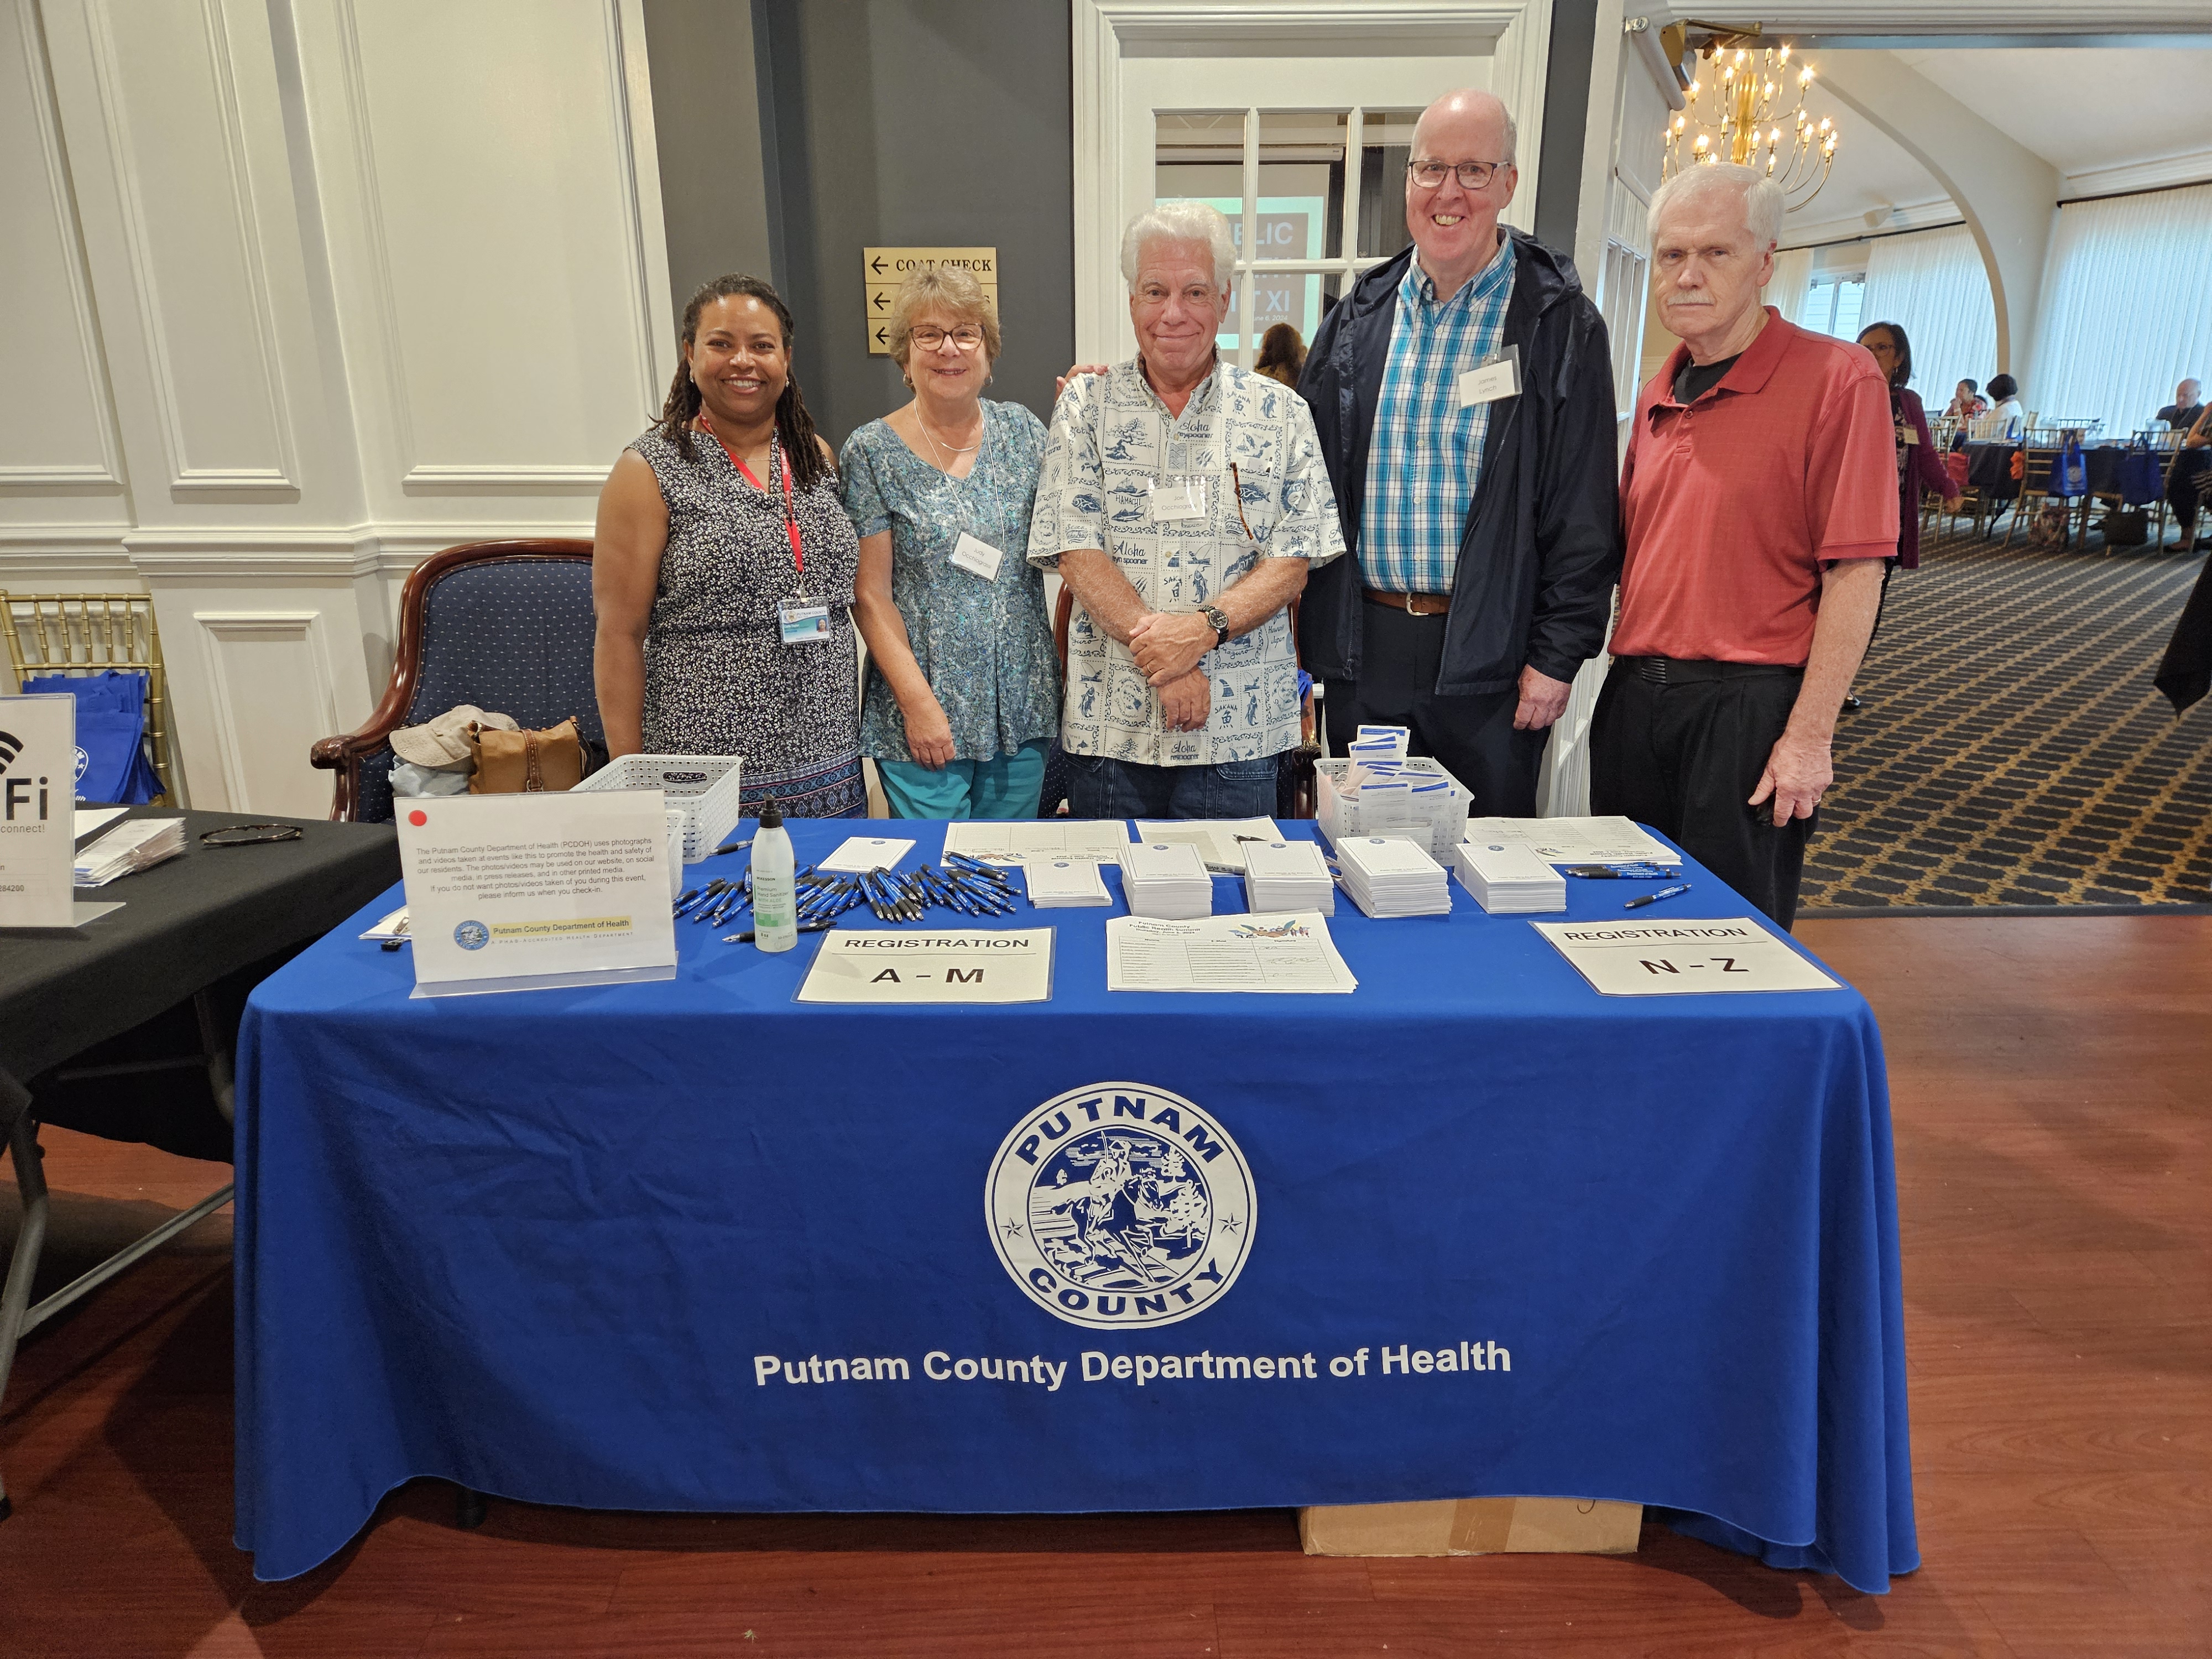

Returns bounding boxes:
[0,0,675,814]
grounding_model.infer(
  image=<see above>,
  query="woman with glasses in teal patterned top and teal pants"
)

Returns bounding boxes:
[838,268,1060,818]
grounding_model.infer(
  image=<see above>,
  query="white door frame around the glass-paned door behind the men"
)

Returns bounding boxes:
[1068,0,1551,363]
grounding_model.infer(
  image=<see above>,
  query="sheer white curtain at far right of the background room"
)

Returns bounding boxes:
[2022,184,2212,438]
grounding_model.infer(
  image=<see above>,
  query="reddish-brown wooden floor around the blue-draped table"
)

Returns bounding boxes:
[0,916,2212,1659]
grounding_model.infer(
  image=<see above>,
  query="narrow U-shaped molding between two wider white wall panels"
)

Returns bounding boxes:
[84,0,299,493]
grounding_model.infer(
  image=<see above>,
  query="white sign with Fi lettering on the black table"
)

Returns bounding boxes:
[0,692,122,931]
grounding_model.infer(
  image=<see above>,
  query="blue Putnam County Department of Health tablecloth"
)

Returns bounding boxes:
[237,823,1918,1590]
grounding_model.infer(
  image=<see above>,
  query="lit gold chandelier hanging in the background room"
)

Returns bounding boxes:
[1661,24,1840,212]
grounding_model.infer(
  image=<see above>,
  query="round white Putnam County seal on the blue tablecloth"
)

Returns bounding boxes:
[984,1084,1259,1329]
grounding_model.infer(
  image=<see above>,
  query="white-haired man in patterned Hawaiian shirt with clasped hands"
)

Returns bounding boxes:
[1029,201,1345,818]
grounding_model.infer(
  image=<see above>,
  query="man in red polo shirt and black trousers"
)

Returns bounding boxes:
[1590,164,1898,929]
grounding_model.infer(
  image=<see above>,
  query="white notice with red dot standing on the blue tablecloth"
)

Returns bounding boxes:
[398,790,677,998]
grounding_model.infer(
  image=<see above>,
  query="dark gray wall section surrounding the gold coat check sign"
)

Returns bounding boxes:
[752,0,1075,442]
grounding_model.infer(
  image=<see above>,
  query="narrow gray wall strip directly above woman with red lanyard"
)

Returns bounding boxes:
[646,0,779,334]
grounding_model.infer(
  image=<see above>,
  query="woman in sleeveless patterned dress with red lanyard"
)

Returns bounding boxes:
[591,276,867,818]
